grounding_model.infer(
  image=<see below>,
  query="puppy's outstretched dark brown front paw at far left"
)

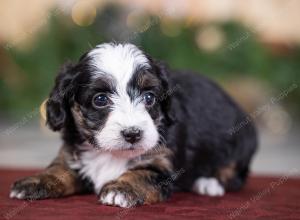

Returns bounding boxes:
[9,174,63,200]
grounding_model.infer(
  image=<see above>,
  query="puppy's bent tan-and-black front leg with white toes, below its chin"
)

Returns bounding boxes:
[99,150,172,207]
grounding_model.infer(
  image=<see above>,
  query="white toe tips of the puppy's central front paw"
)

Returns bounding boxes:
[100,192,132,208]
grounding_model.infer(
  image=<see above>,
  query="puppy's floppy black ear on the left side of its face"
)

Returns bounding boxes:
[46,63,75,131]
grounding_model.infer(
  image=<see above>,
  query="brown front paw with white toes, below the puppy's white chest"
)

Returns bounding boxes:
[99,182,144,208]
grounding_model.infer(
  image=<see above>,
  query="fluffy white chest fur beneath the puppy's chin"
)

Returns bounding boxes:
[71,151,128,193]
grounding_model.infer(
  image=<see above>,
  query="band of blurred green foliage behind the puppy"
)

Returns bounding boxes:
[0,5,300,115]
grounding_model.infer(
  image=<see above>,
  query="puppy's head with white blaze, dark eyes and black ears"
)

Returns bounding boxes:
[47,44,169,156]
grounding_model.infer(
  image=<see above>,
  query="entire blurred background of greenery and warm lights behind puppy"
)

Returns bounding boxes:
[0,0,300,175]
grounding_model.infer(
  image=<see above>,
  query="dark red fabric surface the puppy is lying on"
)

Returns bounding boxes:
[0,170,300,220]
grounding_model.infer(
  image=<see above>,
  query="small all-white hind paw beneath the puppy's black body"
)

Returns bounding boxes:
[193,177,225,196]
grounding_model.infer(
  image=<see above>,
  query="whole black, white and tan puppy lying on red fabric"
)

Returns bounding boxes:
[10,43,257,207]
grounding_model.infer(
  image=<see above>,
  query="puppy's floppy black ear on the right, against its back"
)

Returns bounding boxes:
[152,60,175,125]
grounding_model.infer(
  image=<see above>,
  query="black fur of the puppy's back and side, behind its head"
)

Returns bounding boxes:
[167,71,257,190]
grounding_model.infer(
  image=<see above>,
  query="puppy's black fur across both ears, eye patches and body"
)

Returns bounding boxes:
[47,43,257,194]
